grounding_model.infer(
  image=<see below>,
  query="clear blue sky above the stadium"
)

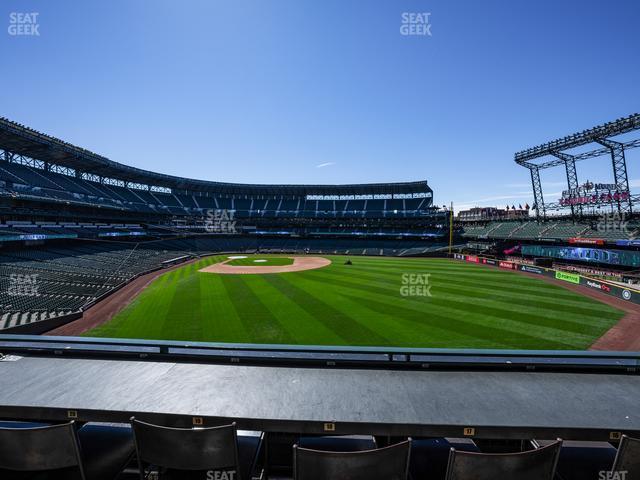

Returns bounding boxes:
[0,0,640,207]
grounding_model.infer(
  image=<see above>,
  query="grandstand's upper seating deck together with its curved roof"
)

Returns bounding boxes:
[0,119,434,234]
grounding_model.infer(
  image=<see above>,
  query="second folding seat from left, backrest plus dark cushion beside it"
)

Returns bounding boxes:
[131,418,263,480]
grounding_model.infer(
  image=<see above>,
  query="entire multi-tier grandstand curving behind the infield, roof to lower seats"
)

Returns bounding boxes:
[0,119,448,333]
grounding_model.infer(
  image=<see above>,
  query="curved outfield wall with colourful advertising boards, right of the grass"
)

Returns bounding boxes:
[453,253,640,304]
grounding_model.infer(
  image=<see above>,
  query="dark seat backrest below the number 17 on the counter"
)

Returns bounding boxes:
[446,440,562,480]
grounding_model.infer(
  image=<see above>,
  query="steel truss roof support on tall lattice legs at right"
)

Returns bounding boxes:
[514,113,640,217]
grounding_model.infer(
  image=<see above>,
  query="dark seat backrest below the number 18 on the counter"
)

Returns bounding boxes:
[293,439,411,480]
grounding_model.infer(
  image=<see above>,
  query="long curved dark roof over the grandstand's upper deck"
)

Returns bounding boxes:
[0,117,433,196]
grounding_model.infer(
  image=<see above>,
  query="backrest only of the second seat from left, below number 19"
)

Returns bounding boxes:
[131,418,238,471]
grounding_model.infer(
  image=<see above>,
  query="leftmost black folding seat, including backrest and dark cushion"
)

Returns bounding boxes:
[0,422,133,480]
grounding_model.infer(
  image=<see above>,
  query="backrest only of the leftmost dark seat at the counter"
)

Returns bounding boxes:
[0,422,85,479]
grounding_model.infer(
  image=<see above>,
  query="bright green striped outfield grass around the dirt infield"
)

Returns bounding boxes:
[87,255,623,349]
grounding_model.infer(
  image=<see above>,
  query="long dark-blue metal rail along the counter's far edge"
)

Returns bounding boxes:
[0,334,640,374]
